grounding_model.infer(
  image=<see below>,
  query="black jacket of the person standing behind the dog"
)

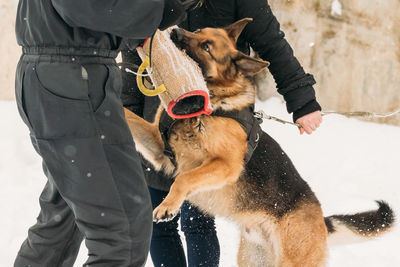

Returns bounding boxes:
[122,0,321,121]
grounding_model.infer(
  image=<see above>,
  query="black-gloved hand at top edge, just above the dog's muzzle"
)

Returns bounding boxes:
[158,0,198,31]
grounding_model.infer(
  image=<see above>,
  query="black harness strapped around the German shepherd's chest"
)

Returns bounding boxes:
[159,105,262,167]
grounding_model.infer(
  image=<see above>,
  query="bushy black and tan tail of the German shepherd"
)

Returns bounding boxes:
[325,201,395,246]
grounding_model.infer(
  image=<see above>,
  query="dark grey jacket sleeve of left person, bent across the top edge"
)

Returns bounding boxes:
[51,0,164,39]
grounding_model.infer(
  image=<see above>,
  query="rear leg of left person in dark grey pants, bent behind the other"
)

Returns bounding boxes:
[14,171,83,267]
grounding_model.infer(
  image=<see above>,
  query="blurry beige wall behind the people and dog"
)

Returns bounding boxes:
[0,0,400,125]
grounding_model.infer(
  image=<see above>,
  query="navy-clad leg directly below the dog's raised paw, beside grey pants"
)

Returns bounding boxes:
[149,187,186,267]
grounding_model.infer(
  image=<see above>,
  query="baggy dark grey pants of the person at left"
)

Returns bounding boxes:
[14,55,152,267]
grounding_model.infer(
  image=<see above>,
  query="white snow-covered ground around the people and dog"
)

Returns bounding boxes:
[0,98,400,267]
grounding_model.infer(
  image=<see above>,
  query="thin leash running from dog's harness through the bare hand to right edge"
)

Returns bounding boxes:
[254,109,400,128]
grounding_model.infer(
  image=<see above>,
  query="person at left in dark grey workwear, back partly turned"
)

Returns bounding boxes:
[14,0,193,267]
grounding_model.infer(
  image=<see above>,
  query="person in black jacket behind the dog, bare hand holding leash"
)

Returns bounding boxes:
[121,0,321,267]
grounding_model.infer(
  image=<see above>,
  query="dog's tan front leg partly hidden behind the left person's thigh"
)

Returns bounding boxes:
[125,109,174,173]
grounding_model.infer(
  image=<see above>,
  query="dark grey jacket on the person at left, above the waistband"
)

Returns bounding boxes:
[16,0,164,56]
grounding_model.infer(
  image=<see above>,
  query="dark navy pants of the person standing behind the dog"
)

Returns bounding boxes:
[149,187,220,267]
